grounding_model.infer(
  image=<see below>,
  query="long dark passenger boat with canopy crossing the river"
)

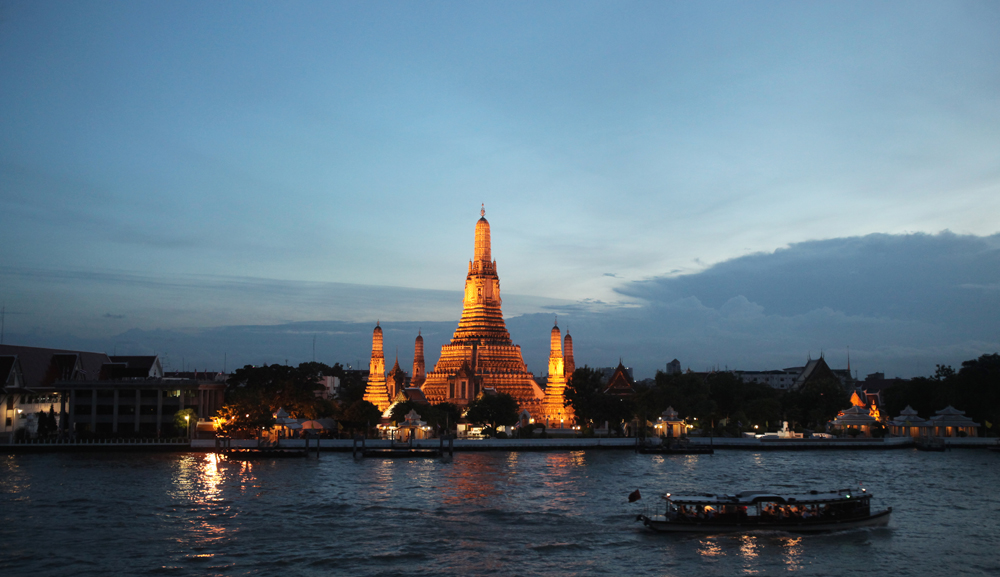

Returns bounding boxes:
[636,489,892,533]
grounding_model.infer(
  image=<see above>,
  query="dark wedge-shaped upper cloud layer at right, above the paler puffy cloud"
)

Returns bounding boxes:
[618,232,1000,337]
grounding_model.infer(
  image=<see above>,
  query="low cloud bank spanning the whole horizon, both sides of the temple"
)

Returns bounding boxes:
[0,232,1000,378]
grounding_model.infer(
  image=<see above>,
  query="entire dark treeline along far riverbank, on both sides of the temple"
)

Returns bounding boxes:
[219,354,1000,435]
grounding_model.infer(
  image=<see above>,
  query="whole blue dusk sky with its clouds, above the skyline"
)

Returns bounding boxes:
[0,0,1000,378]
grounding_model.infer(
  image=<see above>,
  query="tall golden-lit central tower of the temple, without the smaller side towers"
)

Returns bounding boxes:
[423,209,545,413]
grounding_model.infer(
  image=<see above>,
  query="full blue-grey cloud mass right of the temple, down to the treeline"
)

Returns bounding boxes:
[548,232,1000,376]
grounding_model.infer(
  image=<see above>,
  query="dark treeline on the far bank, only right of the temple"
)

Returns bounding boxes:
[566,354,1000,435]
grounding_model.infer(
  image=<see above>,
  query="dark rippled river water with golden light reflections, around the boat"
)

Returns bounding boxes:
[0,449,1000,577]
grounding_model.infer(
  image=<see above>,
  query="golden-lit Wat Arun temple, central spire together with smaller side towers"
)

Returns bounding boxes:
[364,208,575,428]
